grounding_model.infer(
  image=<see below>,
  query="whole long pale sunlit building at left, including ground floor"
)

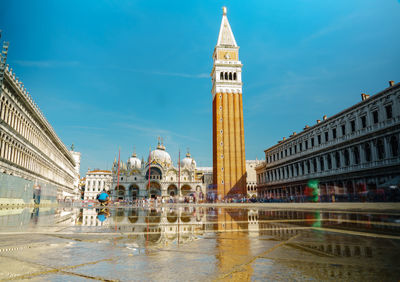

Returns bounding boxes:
[0,43,79,203]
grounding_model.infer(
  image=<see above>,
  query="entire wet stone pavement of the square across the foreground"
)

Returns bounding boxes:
[0,206,400,281]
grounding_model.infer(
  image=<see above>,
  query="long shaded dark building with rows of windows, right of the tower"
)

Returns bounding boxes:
[257,81,400,199]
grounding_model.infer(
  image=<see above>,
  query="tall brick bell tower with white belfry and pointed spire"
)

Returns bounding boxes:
[211,7,247,198]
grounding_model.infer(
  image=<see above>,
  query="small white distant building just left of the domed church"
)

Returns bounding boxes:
[84,169,112,200]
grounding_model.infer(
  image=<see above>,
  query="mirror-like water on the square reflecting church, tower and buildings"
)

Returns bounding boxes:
[0,207,400,280]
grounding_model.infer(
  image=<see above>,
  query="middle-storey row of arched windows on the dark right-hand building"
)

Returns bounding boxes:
[258,135,399,183]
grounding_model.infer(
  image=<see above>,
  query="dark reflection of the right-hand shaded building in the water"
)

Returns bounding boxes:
[256,210,400,281]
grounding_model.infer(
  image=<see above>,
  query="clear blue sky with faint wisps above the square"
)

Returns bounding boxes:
[0,0,400,175]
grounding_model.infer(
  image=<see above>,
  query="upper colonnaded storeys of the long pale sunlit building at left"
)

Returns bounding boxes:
[0,68,78,192]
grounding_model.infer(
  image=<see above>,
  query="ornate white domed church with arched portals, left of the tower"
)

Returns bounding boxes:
[111,140,206,201]
